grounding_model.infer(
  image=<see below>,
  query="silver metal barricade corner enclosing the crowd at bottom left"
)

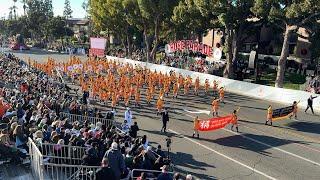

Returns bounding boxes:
[28,138,100,180]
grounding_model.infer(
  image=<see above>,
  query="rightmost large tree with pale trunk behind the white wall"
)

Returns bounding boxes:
[252,0,320,88]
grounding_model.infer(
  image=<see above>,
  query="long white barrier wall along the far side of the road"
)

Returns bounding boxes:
[106,56,320,111]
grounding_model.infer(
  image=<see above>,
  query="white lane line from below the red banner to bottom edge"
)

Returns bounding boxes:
[169,129,276,180]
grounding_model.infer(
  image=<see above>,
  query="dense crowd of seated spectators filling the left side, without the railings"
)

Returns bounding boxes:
[0,54,195,180]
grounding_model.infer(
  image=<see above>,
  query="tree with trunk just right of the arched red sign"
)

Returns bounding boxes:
[194,0,253,78]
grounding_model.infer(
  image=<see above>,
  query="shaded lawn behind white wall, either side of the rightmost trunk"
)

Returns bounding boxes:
[252,69,306,90]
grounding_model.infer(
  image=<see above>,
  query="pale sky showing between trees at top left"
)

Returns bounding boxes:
[0,0,86,18]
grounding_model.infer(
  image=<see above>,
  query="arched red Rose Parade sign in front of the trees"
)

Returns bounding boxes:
[169,40,212,56]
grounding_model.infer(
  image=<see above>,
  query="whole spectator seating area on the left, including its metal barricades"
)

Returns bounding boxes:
[0,54,188,179]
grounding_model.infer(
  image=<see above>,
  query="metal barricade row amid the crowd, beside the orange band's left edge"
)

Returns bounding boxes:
[60,112,114,127]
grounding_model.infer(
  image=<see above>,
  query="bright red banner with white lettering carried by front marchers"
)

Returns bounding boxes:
[198,115,232,131]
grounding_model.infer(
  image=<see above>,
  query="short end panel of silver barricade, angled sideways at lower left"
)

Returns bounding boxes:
[28,138,44,180]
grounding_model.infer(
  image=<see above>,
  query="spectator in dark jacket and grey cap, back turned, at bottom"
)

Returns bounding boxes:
[104,142,125,180]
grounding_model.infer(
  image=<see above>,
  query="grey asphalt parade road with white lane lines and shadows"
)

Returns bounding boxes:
[8,50,320,180]
